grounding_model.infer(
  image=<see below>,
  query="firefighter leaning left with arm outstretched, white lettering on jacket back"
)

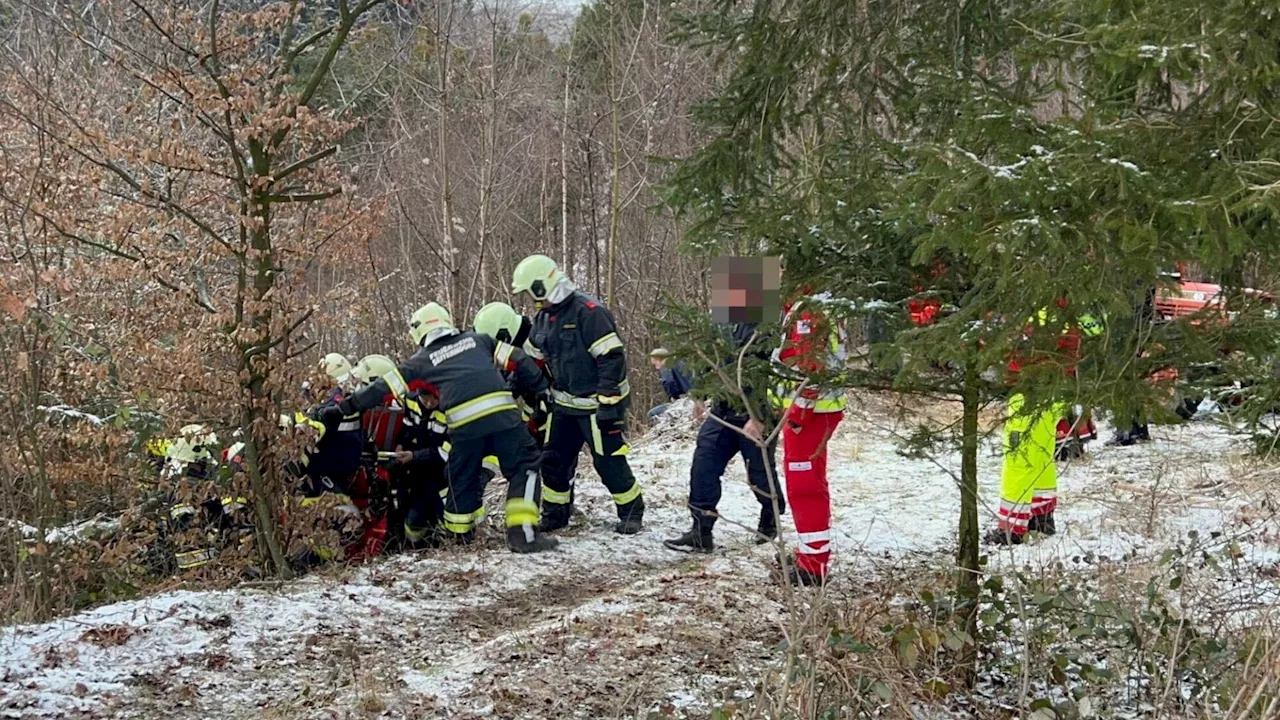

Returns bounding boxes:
[330,302,557,552]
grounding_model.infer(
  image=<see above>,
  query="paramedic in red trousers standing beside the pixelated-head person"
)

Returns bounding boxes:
[777,288,845,585]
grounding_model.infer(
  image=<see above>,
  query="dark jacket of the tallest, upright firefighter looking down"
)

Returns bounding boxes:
[530,291,631,415]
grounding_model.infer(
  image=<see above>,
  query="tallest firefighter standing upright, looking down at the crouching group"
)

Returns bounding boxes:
[511,255,644,534]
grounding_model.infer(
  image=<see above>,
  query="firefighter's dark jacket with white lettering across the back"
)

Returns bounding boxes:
[342,332,538,441]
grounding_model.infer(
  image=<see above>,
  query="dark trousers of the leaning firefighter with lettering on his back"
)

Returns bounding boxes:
[444,428,541,536]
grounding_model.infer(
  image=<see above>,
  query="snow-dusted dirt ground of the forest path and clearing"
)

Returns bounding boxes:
[0,397,1280,719]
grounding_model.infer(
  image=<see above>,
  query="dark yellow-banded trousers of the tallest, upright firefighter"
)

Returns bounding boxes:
[543,409,640,519]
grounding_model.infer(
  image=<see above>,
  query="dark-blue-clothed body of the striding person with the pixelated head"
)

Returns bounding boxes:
[663,323,786,553]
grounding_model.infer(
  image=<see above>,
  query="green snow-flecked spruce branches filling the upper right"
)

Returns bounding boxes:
[667,0,1280,425]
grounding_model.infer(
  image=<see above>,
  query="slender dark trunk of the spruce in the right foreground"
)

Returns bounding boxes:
[956,368,982,688]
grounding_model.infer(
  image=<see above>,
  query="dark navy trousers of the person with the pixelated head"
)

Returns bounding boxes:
[689,418,787,532]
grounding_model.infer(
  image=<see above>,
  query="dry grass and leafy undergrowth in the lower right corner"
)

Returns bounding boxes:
[713,532,1280,720]
